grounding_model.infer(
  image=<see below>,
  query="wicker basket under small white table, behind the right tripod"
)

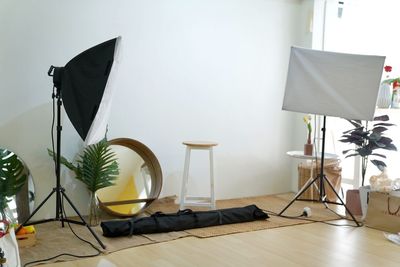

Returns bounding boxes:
[297,160,342,201]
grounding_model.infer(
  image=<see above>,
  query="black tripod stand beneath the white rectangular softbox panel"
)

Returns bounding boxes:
[279,116,361,226]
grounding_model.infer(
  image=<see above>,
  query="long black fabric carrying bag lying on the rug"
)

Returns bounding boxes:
[100,205,269,237]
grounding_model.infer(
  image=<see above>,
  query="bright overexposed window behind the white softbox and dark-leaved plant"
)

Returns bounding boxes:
[313,0,400,188]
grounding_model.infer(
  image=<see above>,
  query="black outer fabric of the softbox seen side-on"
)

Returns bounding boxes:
[60,38,117,140]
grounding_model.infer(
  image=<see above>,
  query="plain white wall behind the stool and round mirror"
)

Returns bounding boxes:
[0,0,312,220]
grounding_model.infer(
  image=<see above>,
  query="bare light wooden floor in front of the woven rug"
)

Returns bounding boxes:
[41,223,400,267]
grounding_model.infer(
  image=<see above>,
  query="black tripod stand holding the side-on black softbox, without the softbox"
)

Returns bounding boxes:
[17,71,106,249]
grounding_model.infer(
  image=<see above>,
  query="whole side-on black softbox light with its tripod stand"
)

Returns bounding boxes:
[17,36,121,249]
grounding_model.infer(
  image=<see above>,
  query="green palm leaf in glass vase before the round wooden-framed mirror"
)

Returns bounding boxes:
[48,138,119,226]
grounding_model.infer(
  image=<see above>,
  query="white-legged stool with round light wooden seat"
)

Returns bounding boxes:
[179,141,218,210]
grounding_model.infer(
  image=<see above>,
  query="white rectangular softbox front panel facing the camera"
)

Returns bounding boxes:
[282,47,385,120]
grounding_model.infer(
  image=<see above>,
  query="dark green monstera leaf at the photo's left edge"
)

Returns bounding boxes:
[0,149,27,211]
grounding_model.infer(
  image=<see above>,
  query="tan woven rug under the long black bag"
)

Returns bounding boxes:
[20,194,346,266]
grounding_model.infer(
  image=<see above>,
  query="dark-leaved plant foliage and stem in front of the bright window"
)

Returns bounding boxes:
[339,115,397,186]
